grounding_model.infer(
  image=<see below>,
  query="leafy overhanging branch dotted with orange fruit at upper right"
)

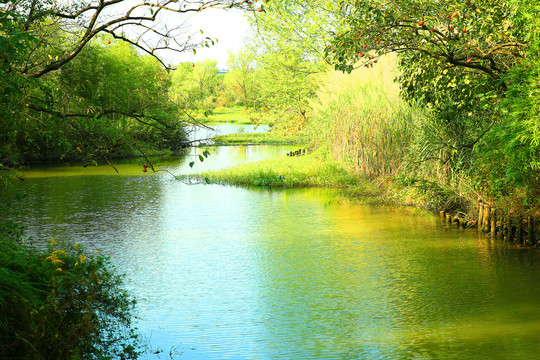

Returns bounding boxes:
[326,0,525,79]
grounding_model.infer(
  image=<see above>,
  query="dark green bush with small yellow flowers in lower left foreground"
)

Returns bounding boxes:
[0,237,140,359]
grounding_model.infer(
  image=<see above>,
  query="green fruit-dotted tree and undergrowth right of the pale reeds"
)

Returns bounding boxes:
[326,0,540,214]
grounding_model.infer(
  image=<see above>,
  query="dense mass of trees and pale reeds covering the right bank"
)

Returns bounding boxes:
[243,0,540,216]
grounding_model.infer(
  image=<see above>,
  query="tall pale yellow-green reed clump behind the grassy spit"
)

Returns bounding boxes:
[308,56,423,177]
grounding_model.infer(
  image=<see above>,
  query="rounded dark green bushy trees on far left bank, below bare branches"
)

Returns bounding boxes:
[0,33,186,164]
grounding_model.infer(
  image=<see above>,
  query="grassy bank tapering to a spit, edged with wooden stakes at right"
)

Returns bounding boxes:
[199,143,540,247]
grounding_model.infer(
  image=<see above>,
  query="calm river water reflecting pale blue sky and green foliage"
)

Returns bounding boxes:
[12,146,540,359]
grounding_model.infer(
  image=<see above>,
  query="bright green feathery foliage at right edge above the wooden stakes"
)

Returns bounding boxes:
[474,3,540,215]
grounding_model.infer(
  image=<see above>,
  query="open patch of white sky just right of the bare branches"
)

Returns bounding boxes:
[166,9,250,70]
